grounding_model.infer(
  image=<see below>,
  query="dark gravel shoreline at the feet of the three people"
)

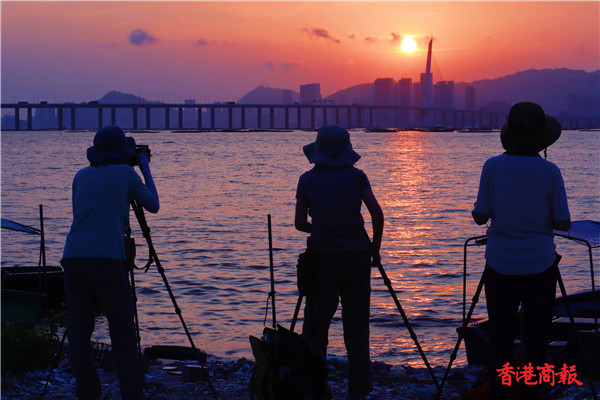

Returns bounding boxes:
[1,356,600,400]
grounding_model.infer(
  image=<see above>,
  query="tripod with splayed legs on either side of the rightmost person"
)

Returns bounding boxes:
[438,264,598,400]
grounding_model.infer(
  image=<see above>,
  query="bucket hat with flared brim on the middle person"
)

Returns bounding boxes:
[303,125,360,168]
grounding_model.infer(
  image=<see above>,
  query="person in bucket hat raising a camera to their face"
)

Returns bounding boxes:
[61,126,160,400]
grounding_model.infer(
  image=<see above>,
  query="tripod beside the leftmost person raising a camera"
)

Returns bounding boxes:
[127,200,217,399]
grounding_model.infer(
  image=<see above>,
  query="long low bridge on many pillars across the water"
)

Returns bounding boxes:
[1,102,600,131]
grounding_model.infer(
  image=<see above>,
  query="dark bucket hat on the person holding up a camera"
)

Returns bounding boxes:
[87,125,135,164]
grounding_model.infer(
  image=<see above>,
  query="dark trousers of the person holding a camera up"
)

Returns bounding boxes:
[61,258,144,400]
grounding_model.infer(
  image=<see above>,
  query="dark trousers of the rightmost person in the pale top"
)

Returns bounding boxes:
[484,259,558,399]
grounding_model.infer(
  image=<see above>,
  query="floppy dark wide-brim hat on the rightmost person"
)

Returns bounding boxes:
[500,102,562,152]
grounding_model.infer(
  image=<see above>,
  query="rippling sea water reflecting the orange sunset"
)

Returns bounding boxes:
[1,130,600,366]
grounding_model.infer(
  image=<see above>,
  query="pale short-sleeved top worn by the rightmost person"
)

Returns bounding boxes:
[475,154,571,275]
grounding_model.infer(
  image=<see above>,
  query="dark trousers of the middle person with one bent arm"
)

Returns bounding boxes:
[302,252,373,395]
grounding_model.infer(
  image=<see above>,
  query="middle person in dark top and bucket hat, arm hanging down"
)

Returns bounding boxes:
[295,125,384,399]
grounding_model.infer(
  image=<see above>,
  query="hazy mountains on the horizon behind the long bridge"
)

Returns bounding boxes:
[92,68,600,116]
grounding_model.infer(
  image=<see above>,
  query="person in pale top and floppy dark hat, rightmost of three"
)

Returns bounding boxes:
[472,102,571,399]
